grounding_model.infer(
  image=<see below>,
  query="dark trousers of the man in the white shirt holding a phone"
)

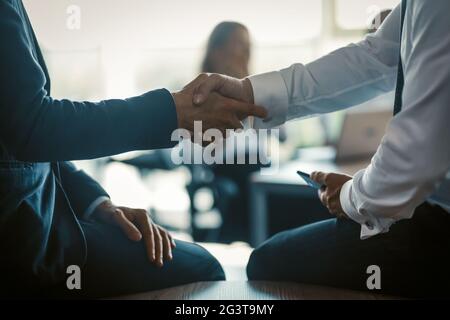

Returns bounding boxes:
[247,204,450,298]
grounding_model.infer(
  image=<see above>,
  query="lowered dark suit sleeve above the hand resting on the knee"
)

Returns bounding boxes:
[59,161,109,219]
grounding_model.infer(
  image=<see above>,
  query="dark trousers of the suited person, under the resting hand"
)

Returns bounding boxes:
[58,222,225,298]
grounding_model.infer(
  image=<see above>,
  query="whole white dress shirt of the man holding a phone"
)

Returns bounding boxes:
[250,0,450,239]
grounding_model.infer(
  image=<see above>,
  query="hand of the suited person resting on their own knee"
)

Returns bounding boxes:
[94,200,176,267]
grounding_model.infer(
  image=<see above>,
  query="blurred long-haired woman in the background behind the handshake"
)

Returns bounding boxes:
[201,21,261,243]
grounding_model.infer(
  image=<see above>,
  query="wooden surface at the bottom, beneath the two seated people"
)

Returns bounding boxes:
[118,281,392,300]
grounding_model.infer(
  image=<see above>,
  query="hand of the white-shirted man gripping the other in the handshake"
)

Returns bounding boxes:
[190,73,254,105]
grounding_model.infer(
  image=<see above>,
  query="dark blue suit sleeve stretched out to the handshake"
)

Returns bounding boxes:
[0,1,177,162]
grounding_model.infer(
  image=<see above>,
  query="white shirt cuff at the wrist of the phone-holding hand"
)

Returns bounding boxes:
[340,180,392,240]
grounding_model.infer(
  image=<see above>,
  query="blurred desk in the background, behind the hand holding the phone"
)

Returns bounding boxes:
[250,147,370,247]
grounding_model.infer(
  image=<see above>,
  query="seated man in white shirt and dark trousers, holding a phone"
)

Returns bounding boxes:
[190,0,450,297]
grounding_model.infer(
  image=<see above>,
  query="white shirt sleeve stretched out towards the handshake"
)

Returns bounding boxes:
[249,6,401,128]
